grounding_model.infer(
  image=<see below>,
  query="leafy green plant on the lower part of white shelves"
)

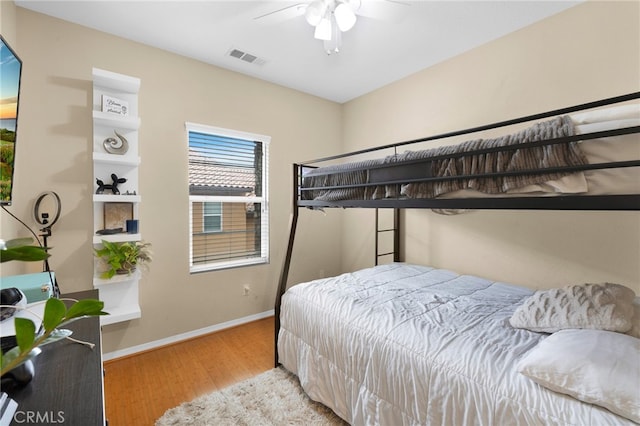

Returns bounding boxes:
[94,240,152,279]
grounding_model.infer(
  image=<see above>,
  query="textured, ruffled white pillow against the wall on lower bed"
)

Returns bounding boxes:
[509,283,635,333]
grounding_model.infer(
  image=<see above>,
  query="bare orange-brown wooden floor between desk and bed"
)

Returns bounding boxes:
[104,317,274,426]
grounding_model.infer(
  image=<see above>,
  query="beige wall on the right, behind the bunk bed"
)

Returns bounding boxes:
[342,2,640,294]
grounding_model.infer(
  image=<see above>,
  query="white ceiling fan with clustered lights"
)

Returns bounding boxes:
[254,0,410,55]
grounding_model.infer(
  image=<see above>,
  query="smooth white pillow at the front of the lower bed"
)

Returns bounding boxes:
[516,330,640,423]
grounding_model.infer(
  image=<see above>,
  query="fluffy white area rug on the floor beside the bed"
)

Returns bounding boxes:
[156,368,346,426]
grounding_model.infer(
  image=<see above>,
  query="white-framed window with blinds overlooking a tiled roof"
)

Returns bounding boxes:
[186,123,270,272]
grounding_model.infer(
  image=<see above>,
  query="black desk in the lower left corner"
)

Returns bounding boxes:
[7,290,105,426]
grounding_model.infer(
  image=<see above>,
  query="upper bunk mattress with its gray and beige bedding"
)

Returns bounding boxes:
[301,104,640,201]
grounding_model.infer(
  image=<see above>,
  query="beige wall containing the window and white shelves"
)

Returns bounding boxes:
[2,7,341,352]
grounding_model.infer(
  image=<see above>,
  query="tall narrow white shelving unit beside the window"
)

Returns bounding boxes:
[92,68,142,325]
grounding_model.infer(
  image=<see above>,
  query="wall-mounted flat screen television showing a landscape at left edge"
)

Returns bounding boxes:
[0,36,22,205]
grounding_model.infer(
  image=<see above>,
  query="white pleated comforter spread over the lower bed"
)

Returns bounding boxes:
[278,263,631,426]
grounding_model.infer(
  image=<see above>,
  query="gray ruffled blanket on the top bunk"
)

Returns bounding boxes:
[302,116,588,201]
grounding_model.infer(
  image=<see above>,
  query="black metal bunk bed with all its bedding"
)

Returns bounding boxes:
[275,92,640,425]
